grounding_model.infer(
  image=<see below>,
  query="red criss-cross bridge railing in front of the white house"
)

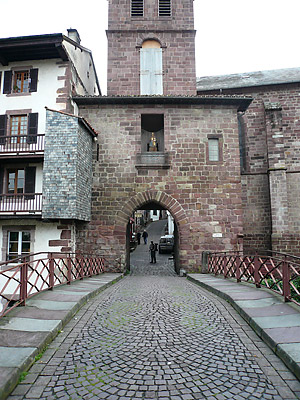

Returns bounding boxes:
[0,253,106,317]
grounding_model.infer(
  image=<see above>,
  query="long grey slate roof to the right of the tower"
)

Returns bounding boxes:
[197,68,300,91]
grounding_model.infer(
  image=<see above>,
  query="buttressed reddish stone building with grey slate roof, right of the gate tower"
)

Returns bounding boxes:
[197,68,300,255]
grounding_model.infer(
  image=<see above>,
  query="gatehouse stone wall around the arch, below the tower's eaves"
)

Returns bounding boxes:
[77,105,242,270]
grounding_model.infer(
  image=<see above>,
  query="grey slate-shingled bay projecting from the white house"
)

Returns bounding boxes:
[42,110,93,221]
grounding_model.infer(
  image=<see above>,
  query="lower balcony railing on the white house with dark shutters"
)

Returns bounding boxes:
[0,193,42,215]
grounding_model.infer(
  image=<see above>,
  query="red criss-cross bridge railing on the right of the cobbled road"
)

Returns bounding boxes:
[208,252,300,305]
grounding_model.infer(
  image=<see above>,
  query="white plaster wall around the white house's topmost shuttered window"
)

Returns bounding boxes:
[0,59,66,134]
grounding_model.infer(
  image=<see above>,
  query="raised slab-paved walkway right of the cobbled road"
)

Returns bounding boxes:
[188,274,300,380]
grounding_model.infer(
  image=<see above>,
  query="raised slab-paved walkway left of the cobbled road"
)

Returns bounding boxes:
[0,273,122,400]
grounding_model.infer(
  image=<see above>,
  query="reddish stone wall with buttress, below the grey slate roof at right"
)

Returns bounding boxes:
[198,83,300,255]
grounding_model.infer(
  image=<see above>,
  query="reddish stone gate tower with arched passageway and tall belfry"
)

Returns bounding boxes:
[74,0,251,271]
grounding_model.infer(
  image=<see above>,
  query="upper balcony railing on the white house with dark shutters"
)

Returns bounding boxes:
[0,135,45,156]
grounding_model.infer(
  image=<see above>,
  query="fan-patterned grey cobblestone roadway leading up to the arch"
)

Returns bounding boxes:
[9,276,300,400]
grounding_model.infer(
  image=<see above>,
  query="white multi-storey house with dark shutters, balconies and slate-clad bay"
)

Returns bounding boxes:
[0,29,101,262]
